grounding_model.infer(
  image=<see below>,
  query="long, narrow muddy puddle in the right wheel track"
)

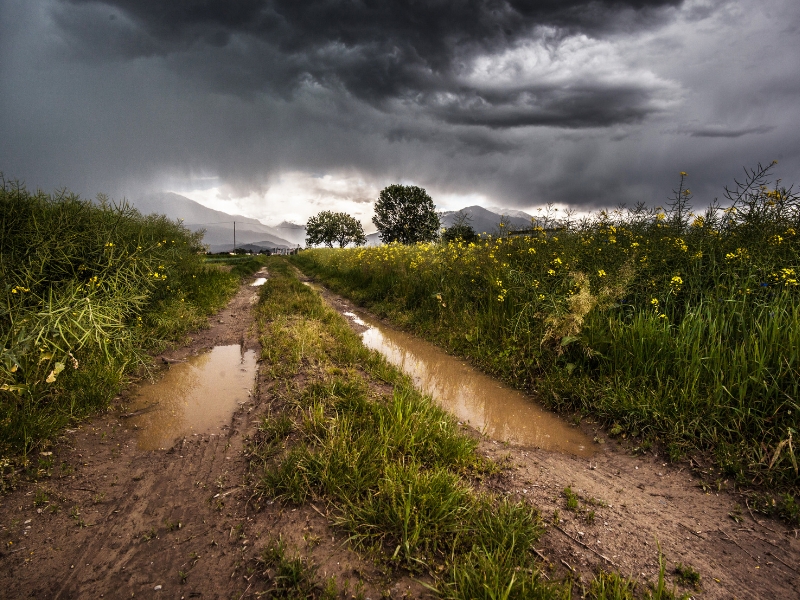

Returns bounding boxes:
[344,313,594,456]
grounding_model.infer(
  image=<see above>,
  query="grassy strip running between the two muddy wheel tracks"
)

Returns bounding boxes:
[249,259,688,599]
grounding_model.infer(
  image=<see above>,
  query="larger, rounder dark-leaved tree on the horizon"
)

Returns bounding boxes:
[372,184,439,244]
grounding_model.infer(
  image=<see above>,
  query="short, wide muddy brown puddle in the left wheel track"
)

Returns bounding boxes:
[129,345,256,450]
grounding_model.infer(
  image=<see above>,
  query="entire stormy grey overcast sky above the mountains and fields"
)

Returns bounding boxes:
[0,0,800,229]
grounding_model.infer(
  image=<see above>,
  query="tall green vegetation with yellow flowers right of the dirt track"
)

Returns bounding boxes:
[292,165,800,523]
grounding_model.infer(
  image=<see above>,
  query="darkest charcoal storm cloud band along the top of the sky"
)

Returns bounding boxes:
[56,0,682,128]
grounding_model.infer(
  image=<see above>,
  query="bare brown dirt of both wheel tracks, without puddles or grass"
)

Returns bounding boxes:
[0,270,800,599]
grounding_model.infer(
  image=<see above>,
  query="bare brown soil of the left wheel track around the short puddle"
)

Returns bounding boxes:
[0,272,412,598]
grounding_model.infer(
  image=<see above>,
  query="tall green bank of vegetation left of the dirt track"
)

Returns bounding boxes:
[0,180,260,471]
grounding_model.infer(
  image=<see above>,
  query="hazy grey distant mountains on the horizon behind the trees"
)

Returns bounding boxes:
[131,192,532,252]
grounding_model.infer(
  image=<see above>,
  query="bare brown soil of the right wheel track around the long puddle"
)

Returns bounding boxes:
[306,274,800,599]
